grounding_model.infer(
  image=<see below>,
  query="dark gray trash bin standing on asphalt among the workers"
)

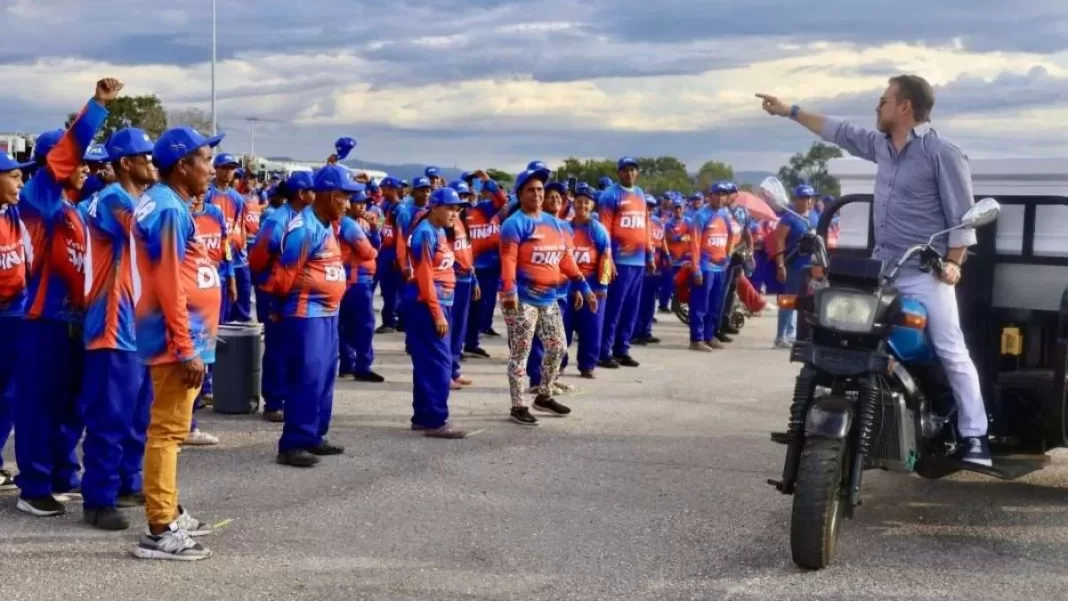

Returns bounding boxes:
[213,323,263,414]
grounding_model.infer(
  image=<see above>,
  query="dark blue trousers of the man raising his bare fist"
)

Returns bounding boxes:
[14,319,84,499]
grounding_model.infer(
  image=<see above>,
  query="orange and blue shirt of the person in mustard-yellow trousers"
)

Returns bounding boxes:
[134,184,222,365]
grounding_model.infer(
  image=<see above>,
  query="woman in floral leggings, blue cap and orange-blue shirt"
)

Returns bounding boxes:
[501,169,597,426]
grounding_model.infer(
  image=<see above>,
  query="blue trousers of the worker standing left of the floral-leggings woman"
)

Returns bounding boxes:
[406,301,453,428]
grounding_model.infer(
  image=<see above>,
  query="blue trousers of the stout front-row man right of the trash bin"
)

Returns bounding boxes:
[278,316,337,453]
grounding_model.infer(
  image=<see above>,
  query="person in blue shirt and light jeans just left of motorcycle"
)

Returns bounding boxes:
[772,184,816,348]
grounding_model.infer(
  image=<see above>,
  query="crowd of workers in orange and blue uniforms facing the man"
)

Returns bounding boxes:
[0,79,833,560]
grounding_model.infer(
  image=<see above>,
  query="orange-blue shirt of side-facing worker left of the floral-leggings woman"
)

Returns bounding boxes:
[405,219,456,321]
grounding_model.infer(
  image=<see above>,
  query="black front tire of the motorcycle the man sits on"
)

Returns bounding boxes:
[790,438,848,570]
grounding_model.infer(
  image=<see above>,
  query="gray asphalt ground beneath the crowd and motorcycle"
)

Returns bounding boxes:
[0,307,1068,601]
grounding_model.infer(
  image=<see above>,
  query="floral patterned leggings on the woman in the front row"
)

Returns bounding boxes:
[501,302,567,407]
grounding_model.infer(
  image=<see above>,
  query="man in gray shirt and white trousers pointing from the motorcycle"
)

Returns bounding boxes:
[757,75,991,465]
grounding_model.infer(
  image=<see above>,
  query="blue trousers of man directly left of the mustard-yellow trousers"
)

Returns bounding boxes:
[81,349,152,509]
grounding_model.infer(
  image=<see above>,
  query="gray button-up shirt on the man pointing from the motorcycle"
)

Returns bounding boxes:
[821,117,975,267]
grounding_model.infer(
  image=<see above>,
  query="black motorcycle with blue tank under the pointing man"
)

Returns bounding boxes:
[759,177,1001,569]
